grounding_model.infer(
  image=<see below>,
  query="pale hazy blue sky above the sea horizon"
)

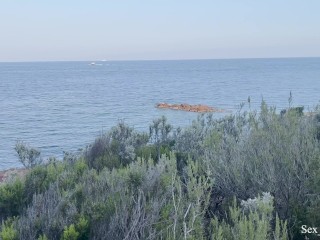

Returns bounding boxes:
[0,0,320,61]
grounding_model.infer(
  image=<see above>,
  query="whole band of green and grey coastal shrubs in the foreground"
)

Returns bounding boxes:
[0,102,320,240]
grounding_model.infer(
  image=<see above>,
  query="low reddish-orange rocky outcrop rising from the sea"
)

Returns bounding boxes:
[156,103,223,113]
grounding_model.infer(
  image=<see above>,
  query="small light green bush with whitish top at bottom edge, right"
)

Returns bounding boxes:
[211,193,288,240]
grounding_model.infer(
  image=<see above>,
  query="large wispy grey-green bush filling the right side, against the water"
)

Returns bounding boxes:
[177,102,320,237]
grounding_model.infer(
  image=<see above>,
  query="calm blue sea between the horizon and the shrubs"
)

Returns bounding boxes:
[0,58,320,169]
